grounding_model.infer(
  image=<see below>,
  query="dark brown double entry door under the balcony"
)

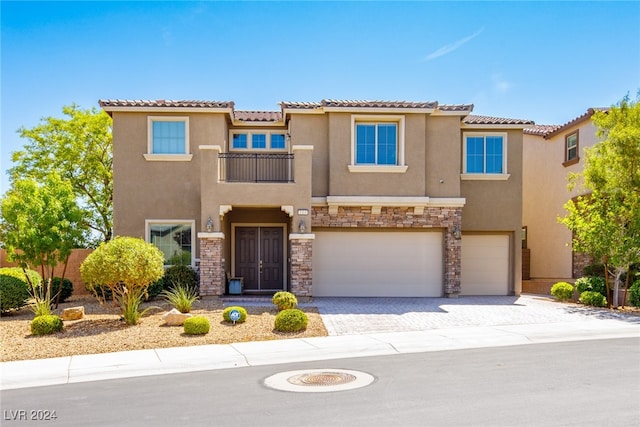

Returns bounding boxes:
[234,226,284,292]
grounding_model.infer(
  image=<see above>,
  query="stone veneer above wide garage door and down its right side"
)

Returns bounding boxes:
[312,206,462,297]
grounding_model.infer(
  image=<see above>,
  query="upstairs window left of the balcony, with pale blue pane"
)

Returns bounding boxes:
[144,116,193,161]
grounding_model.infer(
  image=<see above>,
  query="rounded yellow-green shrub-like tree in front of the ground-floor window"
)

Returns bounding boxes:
[80,237,164,325]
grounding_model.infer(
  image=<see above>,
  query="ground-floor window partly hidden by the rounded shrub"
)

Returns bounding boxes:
[145,219,196,267]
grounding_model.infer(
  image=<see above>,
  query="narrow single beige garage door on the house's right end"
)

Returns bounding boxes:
[460,234,509,295]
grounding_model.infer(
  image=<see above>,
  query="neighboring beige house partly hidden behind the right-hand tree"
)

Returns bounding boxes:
[522,108,598,280]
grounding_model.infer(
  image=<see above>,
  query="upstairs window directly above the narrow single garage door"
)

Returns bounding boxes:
[462,132,509,180]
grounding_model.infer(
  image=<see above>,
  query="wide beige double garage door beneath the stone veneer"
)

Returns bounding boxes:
[313,231,443,297]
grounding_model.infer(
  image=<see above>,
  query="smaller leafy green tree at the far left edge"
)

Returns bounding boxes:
[0,173,84,309]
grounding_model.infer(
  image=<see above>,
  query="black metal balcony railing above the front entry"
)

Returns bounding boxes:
[219,153,293,182]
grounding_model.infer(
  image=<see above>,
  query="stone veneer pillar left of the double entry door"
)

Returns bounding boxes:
[200,237,226,295]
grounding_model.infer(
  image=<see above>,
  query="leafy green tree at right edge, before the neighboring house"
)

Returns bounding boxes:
[560,92,640,307]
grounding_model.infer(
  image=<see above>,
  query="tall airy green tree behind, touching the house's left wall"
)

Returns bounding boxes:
[9,105,113,247]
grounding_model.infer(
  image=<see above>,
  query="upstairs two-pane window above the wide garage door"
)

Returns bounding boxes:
[349,115,407,173]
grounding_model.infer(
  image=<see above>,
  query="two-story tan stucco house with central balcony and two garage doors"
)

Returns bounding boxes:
[100,100,533,297]
